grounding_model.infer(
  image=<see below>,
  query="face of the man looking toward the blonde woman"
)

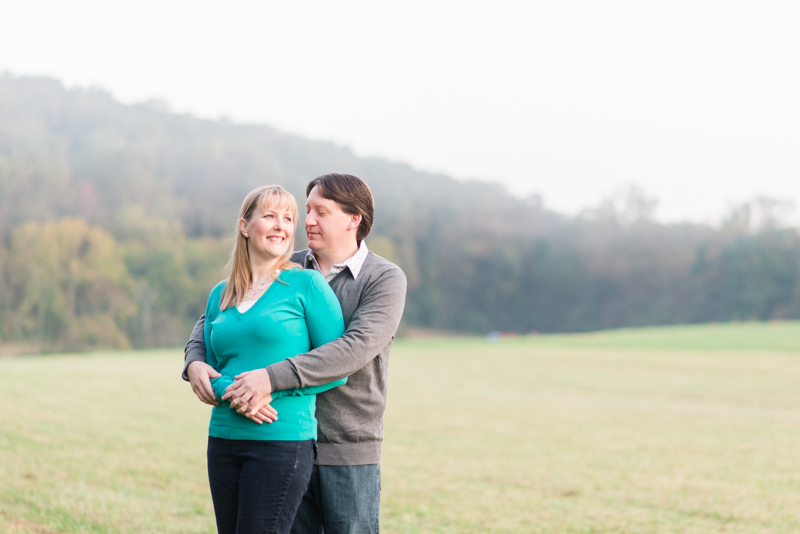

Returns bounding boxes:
[306,187,358,255]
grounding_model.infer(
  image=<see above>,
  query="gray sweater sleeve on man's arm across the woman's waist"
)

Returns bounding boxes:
[267,265,406,390]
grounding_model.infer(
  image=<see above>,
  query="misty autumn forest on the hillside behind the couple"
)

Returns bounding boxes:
[0,74,800,353]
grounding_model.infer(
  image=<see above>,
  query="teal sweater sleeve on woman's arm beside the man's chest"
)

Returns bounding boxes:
[272,271,347,399]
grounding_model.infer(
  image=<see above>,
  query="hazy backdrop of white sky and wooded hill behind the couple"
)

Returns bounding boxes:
[0,1,800,353]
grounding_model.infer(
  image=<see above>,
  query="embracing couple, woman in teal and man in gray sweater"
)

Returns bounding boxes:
[183,174,406,534]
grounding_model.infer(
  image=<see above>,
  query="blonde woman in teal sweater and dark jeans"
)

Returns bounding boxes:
[205,186,346,534]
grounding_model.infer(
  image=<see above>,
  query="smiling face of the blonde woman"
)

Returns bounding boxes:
[244,198,295,260]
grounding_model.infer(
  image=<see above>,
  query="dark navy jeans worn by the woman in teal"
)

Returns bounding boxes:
[208,436,314,534]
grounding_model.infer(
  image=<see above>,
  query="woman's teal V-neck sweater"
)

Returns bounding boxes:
[205,268,347,441]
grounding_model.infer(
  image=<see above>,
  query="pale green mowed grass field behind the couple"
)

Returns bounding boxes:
[0,323,800,533]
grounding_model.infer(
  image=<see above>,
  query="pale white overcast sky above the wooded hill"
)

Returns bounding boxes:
[0,0,800,221]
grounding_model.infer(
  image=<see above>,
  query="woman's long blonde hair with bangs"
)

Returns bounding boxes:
[219,185,299,310]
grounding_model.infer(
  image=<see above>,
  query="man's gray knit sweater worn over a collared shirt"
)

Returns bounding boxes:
[183,250,406,465]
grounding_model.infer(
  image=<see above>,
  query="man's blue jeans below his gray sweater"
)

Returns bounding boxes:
[292,464,381,534]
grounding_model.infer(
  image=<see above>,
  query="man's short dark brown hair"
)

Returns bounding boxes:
[306,173,375,243]
